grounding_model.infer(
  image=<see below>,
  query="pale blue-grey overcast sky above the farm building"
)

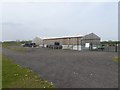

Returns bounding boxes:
[0,0,118,41]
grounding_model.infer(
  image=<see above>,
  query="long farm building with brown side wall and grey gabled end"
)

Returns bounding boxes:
[43,33,100,50]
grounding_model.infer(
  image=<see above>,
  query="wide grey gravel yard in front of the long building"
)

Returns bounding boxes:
[3,48,118,88]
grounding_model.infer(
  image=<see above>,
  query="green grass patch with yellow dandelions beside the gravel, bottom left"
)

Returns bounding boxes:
[2,56,55,88]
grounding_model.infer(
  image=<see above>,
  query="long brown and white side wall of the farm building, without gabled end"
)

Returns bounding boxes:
[43,36,82,50]
